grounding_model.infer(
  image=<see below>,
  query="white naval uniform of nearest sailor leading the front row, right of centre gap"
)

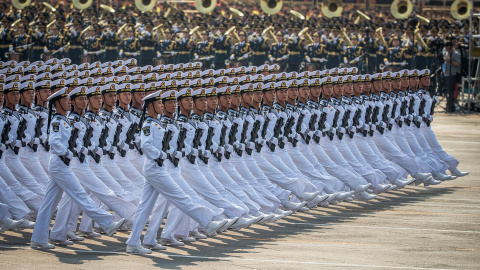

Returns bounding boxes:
[127,117,216,246]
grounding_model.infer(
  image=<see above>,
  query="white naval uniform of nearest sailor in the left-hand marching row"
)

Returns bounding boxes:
[32,114,114,243]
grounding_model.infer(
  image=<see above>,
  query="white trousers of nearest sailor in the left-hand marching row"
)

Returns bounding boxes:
[32,155,114,243]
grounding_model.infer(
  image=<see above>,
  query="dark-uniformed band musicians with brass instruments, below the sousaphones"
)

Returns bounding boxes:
[0,4,478,73]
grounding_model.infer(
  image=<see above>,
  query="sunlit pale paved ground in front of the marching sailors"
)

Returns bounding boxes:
[0,110,480,269]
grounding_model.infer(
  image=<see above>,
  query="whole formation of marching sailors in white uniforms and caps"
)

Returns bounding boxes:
[0,59,468,254]
